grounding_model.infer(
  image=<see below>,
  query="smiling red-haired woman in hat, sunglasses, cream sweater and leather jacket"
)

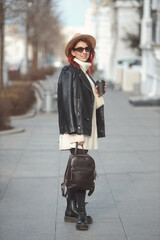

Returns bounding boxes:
[58,33,105,230]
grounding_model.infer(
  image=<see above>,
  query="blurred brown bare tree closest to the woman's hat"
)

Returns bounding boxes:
[27,0,61,71]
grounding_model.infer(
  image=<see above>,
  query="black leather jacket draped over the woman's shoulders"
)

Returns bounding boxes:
[57,64,105,137]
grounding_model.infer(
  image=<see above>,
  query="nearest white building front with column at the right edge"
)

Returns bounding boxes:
[141,0,160,97]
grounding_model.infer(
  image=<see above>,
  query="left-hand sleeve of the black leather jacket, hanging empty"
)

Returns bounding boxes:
[57,68,76,134]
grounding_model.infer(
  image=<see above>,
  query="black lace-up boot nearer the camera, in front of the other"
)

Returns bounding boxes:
[76,202,88,230]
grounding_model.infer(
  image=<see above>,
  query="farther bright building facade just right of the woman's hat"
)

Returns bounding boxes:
[86,0,140,82]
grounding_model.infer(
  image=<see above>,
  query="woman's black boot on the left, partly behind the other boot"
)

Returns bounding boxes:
[64,198,93,224]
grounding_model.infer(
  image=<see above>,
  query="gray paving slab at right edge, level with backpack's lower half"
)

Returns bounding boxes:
[108,172,160,201]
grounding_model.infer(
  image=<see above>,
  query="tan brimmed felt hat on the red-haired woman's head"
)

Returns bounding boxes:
[65,33,96,57]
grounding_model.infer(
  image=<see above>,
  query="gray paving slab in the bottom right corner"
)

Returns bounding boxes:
[117,201,160,239]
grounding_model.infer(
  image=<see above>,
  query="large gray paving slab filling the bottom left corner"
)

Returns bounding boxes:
[0,178,57,240]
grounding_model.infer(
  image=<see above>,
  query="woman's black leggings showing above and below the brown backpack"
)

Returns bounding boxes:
[68,148,88,203]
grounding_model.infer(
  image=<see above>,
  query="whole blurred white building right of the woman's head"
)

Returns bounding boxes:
[86,0,160,96]
